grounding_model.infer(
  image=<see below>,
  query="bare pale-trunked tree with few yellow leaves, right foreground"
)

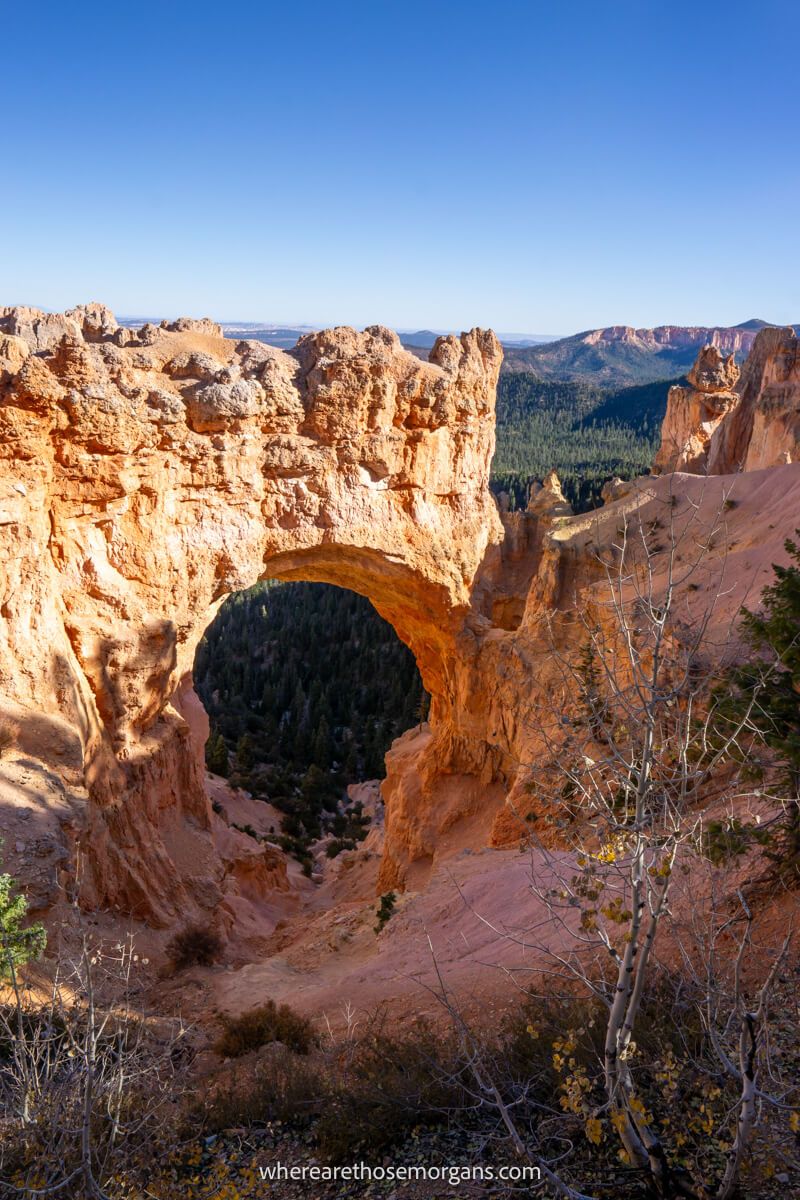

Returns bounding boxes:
[443,482,788,1200]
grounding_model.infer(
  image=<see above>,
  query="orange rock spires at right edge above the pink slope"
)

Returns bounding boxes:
[654,328,800,475]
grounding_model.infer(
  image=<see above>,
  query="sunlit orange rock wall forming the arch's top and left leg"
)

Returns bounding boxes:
[0,305,503,923]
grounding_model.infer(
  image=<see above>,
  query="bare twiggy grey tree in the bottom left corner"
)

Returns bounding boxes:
[0,908,186,1200]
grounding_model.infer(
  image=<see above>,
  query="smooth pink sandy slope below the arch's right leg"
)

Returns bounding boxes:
[212,850,563,1024]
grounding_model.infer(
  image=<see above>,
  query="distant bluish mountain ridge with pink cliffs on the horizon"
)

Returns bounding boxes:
[504,317,799,388]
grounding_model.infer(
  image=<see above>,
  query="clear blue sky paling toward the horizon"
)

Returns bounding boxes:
[0,0,800,334]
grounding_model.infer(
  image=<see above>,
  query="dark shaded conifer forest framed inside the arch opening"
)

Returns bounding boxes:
[194,582,427,836]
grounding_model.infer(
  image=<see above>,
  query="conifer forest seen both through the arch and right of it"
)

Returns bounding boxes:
[194,372,669,856]
